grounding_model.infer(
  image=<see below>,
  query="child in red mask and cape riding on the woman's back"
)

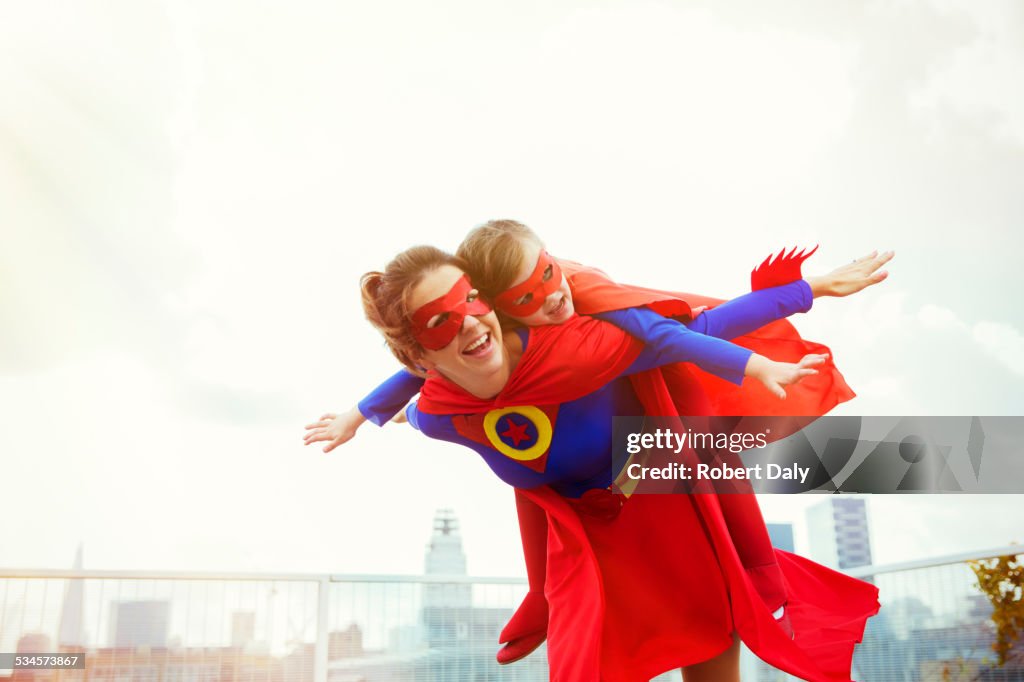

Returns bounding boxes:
[307,221,891,663]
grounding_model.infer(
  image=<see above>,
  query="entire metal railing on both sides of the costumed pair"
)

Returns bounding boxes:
[0,546,1022,682]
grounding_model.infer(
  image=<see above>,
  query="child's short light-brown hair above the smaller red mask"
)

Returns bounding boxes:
[456,220,544,301]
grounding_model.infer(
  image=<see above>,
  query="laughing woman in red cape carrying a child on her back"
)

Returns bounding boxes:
[327,248,878,681]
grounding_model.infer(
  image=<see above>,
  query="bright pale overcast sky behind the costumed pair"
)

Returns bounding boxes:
[0,0,1024,574]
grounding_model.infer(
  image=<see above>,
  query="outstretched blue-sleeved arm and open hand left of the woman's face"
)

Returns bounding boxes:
[305,370,424,453]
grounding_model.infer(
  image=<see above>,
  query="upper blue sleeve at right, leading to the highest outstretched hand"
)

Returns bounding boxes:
[686,280,814,339]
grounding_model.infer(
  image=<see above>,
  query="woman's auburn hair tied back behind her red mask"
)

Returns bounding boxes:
[359,246,467,377]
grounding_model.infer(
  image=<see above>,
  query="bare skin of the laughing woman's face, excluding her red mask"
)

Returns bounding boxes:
[409,265,507,387]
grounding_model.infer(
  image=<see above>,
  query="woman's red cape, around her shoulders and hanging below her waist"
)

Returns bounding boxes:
[420,274,879,682]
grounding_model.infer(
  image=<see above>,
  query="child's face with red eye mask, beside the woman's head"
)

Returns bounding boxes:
[496,241,575,327]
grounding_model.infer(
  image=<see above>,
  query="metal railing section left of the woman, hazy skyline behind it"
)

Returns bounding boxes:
[0,569,544,682]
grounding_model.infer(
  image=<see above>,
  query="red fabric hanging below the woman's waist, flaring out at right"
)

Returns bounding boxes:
[523,486,879,682]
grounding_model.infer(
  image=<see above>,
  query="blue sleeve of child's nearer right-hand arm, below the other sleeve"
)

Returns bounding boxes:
[594,308,753,384]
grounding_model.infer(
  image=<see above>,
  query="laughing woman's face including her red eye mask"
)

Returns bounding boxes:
[409,265,507,388]
